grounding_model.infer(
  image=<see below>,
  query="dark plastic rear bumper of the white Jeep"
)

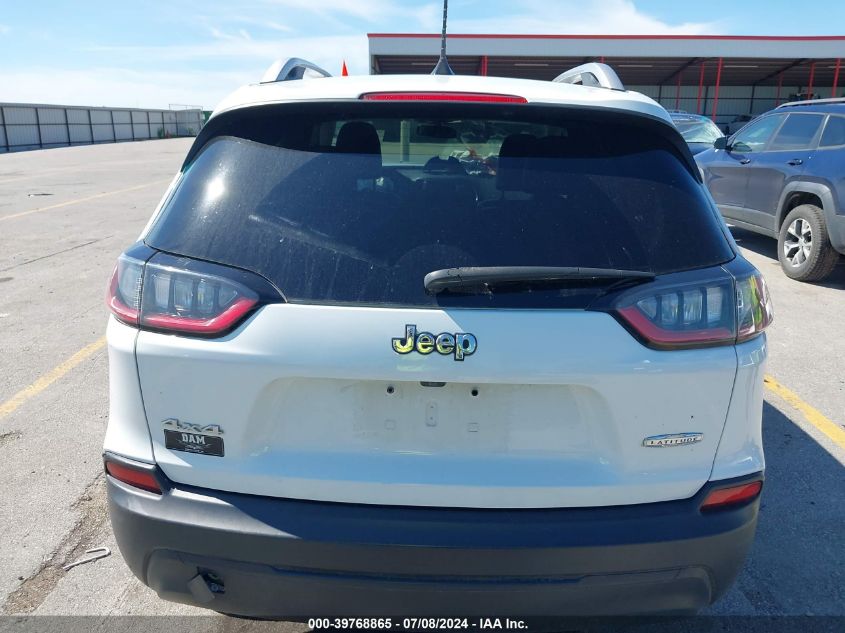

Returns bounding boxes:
[107,454,759,618]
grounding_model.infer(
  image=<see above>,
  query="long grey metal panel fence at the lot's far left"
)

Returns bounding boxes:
[0,103,203,153]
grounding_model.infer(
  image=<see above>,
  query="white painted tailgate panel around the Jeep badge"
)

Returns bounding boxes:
[130,304,764,508]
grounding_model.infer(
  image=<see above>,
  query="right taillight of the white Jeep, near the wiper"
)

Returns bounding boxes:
[615,272,772,349]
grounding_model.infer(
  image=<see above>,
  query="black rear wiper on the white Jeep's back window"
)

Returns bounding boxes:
[424,266,654,294]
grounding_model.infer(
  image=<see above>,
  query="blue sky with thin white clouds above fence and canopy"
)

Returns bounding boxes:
[0,0,845,108]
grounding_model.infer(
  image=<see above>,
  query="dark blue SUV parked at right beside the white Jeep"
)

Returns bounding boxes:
[695,99,845,281]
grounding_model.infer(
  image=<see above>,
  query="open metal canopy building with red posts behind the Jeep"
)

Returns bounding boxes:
[368,33,845,124]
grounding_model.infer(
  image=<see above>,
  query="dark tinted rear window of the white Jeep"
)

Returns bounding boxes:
[146,103,733,307]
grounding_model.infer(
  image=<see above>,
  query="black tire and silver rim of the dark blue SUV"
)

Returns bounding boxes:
[778,204,839,281]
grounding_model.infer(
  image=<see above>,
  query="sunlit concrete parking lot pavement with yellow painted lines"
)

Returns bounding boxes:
[0,139,845,630]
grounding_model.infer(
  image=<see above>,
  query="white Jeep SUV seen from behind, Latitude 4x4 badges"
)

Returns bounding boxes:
[100,62,771,617]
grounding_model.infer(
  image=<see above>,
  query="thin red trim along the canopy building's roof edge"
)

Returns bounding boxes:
[367,33,845,42]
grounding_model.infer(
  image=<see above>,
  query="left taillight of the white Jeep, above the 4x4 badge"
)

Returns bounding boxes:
[107,249,272,336]
